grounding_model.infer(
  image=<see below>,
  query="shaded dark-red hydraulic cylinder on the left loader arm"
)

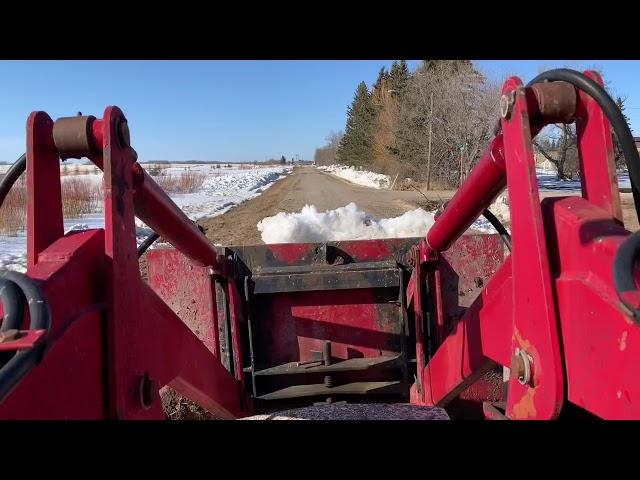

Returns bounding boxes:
[132,162,223,270]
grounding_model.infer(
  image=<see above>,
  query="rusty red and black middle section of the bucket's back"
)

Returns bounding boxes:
[232,239,416,402]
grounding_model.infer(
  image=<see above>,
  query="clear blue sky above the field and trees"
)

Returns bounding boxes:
[0,60,640,161]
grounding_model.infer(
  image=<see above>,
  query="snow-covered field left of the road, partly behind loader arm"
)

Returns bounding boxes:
[0,165,292,271]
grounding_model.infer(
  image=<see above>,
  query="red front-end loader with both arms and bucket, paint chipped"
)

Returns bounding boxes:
[6,72,640,419]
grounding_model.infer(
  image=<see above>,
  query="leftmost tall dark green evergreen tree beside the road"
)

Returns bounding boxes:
[337,82,376,166]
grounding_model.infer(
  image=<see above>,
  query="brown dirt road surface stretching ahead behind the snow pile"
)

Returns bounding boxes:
[199,167,453,246]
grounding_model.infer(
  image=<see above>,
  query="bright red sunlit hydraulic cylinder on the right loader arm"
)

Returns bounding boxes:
[427,134,507,252]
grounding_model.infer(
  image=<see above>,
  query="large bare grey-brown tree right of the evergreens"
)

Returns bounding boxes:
[396,60,500,187]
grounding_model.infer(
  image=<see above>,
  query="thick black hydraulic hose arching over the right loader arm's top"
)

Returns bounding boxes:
[527,68,640,221]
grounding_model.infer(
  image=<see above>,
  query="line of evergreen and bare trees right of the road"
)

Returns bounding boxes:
[314,60,624,186]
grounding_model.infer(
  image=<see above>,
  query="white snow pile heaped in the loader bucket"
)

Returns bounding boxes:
[258,202,433,243]
